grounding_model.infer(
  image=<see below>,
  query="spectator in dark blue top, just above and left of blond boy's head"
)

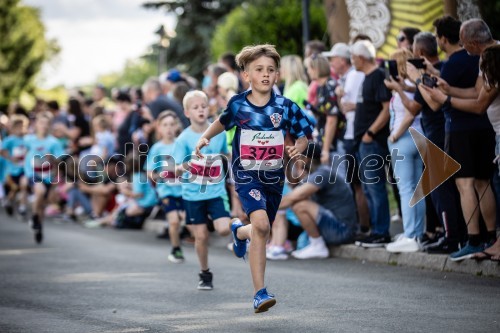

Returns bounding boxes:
[142,78,189,128]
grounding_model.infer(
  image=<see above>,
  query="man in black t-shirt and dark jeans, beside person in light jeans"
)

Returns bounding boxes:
[351,40,392,247]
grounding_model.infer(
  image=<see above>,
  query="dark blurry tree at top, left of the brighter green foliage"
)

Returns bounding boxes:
[143,0,243,77]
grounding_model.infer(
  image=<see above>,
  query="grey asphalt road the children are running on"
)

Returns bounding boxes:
[0,213,500,333]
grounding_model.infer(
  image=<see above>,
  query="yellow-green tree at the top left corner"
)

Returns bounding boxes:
[0,0,59,110]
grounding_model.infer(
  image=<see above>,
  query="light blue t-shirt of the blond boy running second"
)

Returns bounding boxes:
[174,126,228,201]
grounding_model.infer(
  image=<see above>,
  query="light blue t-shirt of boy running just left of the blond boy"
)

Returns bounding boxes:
[145,141,182,199]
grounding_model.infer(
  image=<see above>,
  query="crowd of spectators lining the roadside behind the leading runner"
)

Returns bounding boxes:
[0,16,500,260]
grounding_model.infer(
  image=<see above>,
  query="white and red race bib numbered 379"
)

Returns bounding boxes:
[240,129,284,171]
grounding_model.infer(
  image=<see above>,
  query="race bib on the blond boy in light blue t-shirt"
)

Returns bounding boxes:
[189,154,223,185]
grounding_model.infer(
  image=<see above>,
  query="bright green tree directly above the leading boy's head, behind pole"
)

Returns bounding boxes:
[211,0,327,58]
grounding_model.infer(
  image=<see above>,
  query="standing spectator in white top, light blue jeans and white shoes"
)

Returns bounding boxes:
[387,49,425,252]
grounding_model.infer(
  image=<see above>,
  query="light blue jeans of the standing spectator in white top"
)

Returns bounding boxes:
[389,131,425,238]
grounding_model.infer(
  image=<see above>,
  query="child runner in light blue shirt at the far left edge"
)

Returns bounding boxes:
[1,115,29,216]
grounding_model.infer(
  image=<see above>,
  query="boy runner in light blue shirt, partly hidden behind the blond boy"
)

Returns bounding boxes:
[146,111,184,264]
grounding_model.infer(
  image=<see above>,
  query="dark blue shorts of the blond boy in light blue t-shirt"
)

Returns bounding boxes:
[184,197,230,224]
